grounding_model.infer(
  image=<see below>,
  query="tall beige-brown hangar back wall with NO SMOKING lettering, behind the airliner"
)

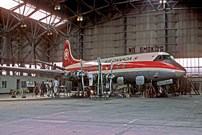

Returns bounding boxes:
[70,6,202,60]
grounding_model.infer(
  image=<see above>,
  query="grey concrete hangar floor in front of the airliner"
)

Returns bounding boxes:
[0,94,202,135]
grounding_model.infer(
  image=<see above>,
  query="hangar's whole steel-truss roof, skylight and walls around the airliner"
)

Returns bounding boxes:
[0,0,202,93]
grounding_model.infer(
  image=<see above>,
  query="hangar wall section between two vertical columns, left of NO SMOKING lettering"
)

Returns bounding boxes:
[83,18,124,59]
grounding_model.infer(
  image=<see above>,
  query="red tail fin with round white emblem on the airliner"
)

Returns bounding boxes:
[62,40,80,67]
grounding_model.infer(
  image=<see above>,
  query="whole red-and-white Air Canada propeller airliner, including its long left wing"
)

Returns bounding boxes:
[0,40,186,92]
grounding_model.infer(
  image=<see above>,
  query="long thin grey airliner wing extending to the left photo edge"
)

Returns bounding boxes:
[0,66,66,75]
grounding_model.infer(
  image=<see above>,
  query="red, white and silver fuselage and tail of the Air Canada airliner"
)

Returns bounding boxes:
[63,40,186,83]
